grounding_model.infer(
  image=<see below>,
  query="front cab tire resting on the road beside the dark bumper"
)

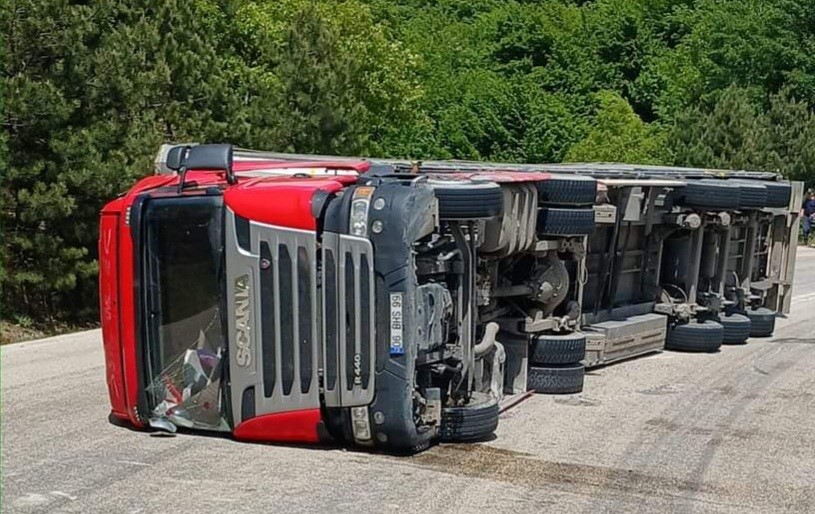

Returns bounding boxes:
[439,393,498,442]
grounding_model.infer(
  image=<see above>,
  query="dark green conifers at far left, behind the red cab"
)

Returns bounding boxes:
[2,0,247,319]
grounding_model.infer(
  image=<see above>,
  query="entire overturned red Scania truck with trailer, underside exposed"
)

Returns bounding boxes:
[99,145,802,452]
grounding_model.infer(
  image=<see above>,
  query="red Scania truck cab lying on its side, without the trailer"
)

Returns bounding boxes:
[99,145,516,451]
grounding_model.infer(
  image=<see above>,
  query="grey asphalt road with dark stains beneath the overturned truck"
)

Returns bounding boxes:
[2,248,815,513]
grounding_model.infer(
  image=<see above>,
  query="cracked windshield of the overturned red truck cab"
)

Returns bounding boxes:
[143,195,228,430]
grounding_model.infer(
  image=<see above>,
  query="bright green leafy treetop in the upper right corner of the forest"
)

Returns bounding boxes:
[649,0,813,117]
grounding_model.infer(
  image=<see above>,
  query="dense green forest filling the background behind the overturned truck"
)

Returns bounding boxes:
[0,0,815,323]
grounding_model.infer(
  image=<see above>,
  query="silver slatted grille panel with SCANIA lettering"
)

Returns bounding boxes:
[226,211,320,418]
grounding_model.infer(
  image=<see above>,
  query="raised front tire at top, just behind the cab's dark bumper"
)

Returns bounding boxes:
[428,178,504,220]
